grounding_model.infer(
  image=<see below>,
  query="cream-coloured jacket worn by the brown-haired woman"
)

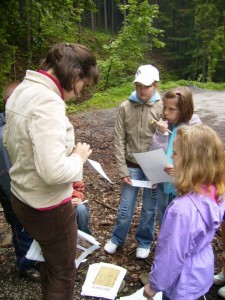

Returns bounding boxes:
[4,70,83,208]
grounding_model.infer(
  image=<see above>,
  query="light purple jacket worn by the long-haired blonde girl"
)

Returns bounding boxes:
[149,193,225,300]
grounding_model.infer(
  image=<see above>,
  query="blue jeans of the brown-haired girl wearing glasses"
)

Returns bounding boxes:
[157,183,176,227]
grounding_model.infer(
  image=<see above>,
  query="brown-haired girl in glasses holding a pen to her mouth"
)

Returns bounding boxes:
[150,86,201,226]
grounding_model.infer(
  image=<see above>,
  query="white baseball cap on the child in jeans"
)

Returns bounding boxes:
[133,65,159,86]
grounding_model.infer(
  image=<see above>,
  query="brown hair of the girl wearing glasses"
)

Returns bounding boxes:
[163,86,194,123]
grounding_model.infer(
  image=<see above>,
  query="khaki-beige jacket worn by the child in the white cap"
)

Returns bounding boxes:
[114,92,163,178]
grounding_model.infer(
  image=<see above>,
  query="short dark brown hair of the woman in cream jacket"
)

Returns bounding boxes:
[40,43,99,92]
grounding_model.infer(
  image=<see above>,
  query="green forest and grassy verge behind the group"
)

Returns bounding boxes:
[0,0,225,112]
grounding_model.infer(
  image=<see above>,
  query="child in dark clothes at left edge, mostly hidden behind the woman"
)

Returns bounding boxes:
[0,81,40,282]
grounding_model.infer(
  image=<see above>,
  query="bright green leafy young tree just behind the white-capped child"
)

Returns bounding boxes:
[99,0,164,88]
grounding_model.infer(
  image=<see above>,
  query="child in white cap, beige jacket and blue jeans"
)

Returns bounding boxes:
[104,65,163,259]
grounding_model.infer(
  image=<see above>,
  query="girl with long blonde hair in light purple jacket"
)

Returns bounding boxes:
[144,124,225,300]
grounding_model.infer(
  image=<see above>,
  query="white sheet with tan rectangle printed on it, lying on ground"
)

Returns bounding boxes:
[81,262,127,300]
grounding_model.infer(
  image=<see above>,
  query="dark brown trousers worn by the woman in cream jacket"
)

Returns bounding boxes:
[12,195,77,300]
